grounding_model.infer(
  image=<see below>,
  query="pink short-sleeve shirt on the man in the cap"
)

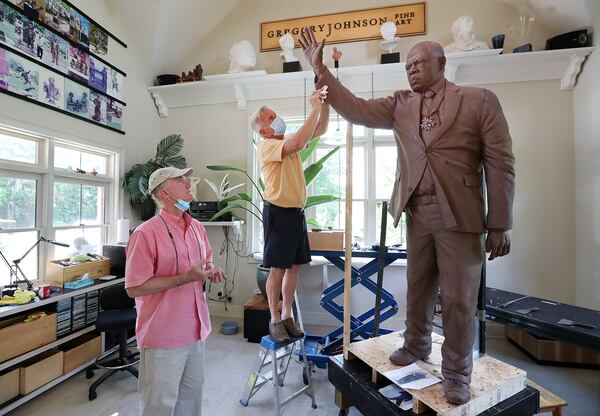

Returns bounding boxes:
[125,210,212,348]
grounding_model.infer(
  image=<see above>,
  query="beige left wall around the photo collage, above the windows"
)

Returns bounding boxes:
[0,0,160,224]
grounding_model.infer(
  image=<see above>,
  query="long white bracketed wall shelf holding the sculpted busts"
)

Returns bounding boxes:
[148,47,595,117]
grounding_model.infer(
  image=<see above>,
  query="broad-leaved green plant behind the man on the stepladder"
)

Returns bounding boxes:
[206,137,340,226]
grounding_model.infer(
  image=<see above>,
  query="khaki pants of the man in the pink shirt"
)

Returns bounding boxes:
[139,341,204,416]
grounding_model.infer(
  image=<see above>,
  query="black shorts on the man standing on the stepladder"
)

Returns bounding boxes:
[263,201,311,269]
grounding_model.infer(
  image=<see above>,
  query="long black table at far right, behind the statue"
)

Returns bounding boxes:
[485,287,600,352]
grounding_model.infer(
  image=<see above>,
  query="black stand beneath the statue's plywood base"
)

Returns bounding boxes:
[327,356,540,416]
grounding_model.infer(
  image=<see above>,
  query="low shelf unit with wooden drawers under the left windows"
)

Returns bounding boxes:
[0,277,125,416]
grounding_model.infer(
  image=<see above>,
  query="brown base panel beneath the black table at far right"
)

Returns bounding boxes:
[506,325,600,365]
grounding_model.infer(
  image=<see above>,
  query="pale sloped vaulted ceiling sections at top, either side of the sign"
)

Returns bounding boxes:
[106,0,599,74]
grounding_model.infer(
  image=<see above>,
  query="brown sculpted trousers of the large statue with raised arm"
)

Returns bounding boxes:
[404,203,483,383]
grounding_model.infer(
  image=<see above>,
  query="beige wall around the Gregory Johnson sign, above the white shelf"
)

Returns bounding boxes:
[177,0,548,74]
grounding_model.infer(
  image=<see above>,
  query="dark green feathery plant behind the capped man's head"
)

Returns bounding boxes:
[122,134,187,221]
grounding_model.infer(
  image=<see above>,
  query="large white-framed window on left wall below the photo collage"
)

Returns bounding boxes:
[0,126,119,285]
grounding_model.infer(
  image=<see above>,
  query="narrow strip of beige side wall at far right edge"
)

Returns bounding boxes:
[573,0,600,309]
